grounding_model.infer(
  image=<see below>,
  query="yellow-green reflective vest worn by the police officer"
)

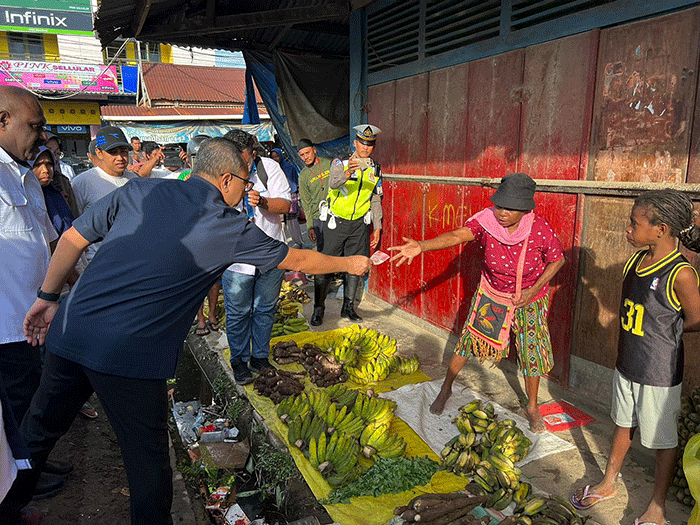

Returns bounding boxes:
[328,160,382,221]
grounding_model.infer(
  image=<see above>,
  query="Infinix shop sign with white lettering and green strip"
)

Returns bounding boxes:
[0,1,92,35]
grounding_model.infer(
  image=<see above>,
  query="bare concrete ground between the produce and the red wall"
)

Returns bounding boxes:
[201,283,690,525]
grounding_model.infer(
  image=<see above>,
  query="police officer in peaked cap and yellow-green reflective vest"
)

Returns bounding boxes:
[311,124,382,326]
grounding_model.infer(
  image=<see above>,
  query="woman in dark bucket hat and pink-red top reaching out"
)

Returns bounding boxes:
[389,173,565,432]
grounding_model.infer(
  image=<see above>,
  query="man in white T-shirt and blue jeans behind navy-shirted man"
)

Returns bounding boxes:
[221,129,292,385]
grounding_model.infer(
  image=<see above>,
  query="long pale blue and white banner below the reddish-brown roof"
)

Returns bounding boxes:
[113,120,275,144]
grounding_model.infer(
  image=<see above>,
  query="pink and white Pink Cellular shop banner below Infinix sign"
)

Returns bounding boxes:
[0,60,119,93]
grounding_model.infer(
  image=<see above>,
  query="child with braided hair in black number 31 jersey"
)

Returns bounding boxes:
[571,190,700,525]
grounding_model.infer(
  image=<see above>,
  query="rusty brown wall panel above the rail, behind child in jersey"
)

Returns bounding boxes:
[589,8,700,182]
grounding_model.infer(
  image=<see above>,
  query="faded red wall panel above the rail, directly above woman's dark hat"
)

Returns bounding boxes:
[464,50,524,177]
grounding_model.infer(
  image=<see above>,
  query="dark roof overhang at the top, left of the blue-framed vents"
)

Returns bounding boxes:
[95,0,352,56]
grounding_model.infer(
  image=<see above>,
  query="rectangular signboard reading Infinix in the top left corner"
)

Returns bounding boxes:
[0,0,93,35]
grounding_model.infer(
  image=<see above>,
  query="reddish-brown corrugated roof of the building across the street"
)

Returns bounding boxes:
[143,63,261,105]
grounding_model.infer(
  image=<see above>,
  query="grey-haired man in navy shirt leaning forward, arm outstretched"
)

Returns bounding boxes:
[5,138,369,525]
